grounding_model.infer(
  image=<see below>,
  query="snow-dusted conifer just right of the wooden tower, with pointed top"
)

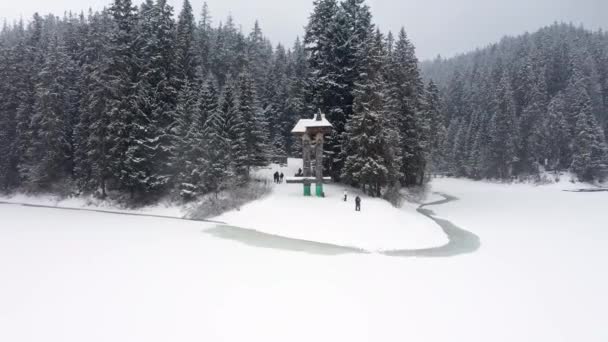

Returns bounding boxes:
[342,31,400,196]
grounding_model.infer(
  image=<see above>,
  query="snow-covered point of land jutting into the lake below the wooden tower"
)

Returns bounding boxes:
[213,159,448,251]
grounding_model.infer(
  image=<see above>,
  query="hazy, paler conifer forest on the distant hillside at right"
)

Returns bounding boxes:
[422,23,608,181]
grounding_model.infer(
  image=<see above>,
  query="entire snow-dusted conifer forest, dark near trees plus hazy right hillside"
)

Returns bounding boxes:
[0,0,608,201]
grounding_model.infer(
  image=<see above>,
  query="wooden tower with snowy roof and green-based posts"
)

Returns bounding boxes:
[287,112,333,197]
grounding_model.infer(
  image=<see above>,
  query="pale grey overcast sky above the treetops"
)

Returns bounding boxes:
[0,0,608,59]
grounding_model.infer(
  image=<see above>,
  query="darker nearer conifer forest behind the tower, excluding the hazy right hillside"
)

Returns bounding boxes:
[0,0,434,200]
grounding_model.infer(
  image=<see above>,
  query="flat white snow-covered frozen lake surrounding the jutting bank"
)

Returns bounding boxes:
[0,179,608,342]
